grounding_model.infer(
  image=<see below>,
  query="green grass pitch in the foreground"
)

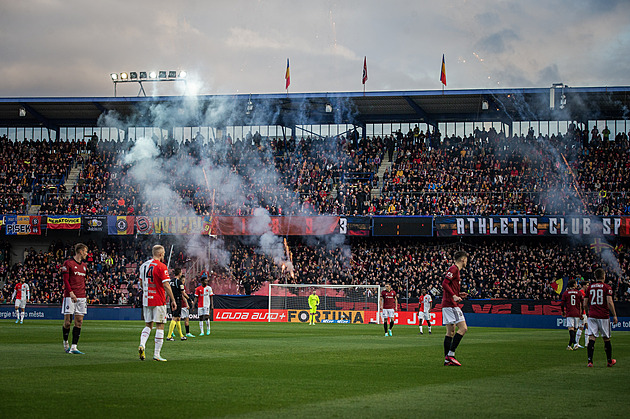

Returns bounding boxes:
[0,320,630,418]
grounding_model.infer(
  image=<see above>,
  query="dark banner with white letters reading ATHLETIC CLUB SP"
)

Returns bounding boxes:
[434,215,630,237]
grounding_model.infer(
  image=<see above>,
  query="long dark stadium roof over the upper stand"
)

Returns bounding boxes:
[0,85,630,129]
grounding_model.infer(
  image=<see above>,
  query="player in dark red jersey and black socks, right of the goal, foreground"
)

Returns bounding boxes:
[442,251,468,367]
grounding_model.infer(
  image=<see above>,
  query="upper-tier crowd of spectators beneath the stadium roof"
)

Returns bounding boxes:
[0,125,630,215]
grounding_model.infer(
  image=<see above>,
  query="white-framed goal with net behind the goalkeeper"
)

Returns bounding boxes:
[269,284,381,323]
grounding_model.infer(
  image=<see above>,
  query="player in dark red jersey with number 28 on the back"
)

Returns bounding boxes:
[586,268,617,367]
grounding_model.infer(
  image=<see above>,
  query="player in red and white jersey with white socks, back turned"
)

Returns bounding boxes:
[138,244,177,361]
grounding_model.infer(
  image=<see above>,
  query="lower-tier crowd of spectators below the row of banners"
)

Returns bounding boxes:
[0,238,630,305]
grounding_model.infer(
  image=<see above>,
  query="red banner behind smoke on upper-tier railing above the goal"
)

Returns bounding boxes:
[203,216,340,236]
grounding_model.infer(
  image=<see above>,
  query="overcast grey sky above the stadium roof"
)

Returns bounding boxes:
[0,0,630,97]
